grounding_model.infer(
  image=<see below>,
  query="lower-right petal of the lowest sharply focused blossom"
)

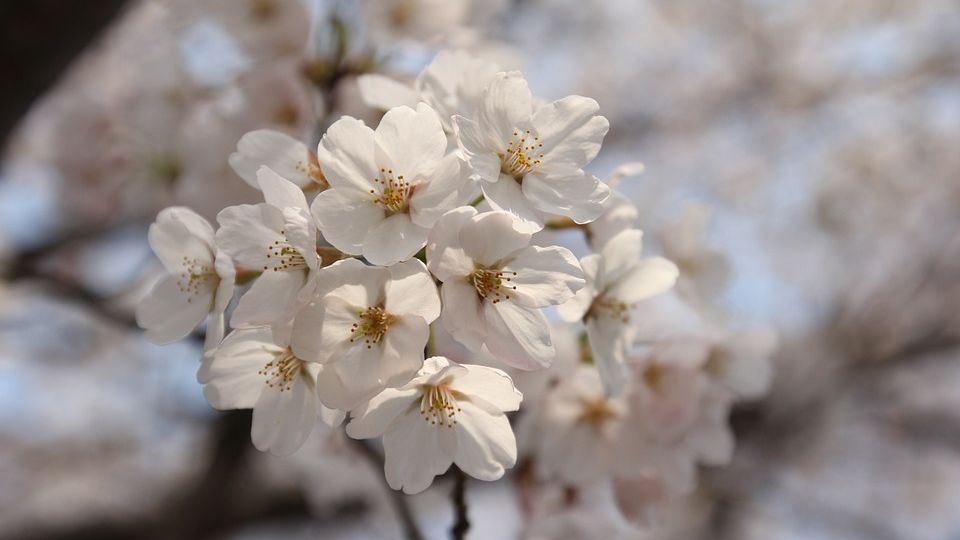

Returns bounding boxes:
[454,402,517,481]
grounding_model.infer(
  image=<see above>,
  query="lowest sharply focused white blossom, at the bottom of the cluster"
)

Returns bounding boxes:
[347,356,523,493]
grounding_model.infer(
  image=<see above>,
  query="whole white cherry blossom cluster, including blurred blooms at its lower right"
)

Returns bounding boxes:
[138,51,776,520]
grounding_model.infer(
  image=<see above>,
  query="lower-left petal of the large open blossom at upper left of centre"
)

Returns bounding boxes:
[310,189,385,255]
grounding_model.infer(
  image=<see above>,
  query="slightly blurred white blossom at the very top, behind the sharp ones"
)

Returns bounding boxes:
[357,50,500,133]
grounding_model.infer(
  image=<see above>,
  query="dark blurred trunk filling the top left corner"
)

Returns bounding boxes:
[0,0,127,151]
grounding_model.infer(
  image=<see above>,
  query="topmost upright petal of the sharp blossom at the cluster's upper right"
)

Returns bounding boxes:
[477,71,533,144]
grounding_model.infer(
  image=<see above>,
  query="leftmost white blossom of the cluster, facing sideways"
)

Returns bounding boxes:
[137,206,234,348]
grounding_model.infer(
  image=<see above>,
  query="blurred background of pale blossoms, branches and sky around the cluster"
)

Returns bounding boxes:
[0,0,960,540]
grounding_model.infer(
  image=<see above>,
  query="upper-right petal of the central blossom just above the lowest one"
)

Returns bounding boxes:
[384,259,440,324]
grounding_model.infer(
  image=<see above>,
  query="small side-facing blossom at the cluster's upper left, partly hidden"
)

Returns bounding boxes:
[229,129,326,189]
